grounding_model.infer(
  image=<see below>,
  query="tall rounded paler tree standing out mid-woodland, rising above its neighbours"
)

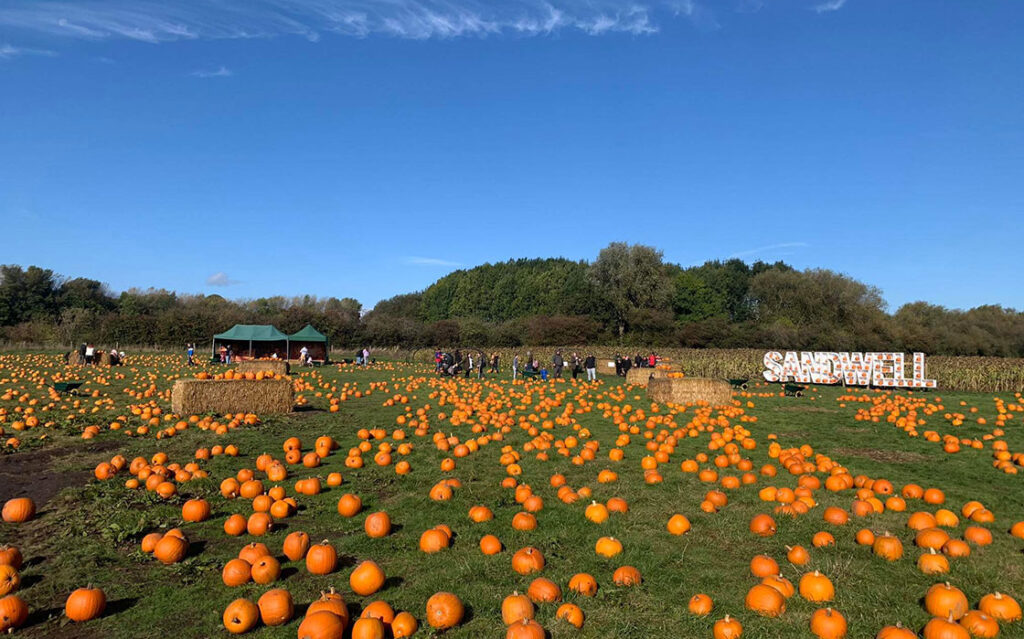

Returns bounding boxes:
[590,242,671,339]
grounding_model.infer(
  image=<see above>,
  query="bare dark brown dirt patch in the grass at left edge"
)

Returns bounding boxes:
[0,441,118,509]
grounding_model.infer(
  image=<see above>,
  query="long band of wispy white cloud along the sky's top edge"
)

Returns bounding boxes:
[0,0,712,43]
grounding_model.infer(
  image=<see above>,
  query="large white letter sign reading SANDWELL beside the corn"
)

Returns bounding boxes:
[763,350,937,388]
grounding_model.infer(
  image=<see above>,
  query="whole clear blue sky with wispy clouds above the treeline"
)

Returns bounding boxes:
[0,0,1024,309]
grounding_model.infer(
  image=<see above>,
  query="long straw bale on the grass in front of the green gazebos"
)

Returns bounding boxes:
[171,379,295,416]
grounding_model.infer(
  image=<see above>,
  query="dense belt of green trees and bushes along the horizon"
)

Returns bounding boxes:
[6,243,1024,356]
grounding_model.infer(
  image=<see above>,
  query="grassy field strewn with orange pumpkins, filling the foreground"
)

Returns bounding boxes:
[0,352,1024,639]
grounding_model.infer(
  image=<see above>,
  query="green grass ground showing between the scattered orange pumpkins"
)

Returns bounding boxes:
[0,356,1024,639]
